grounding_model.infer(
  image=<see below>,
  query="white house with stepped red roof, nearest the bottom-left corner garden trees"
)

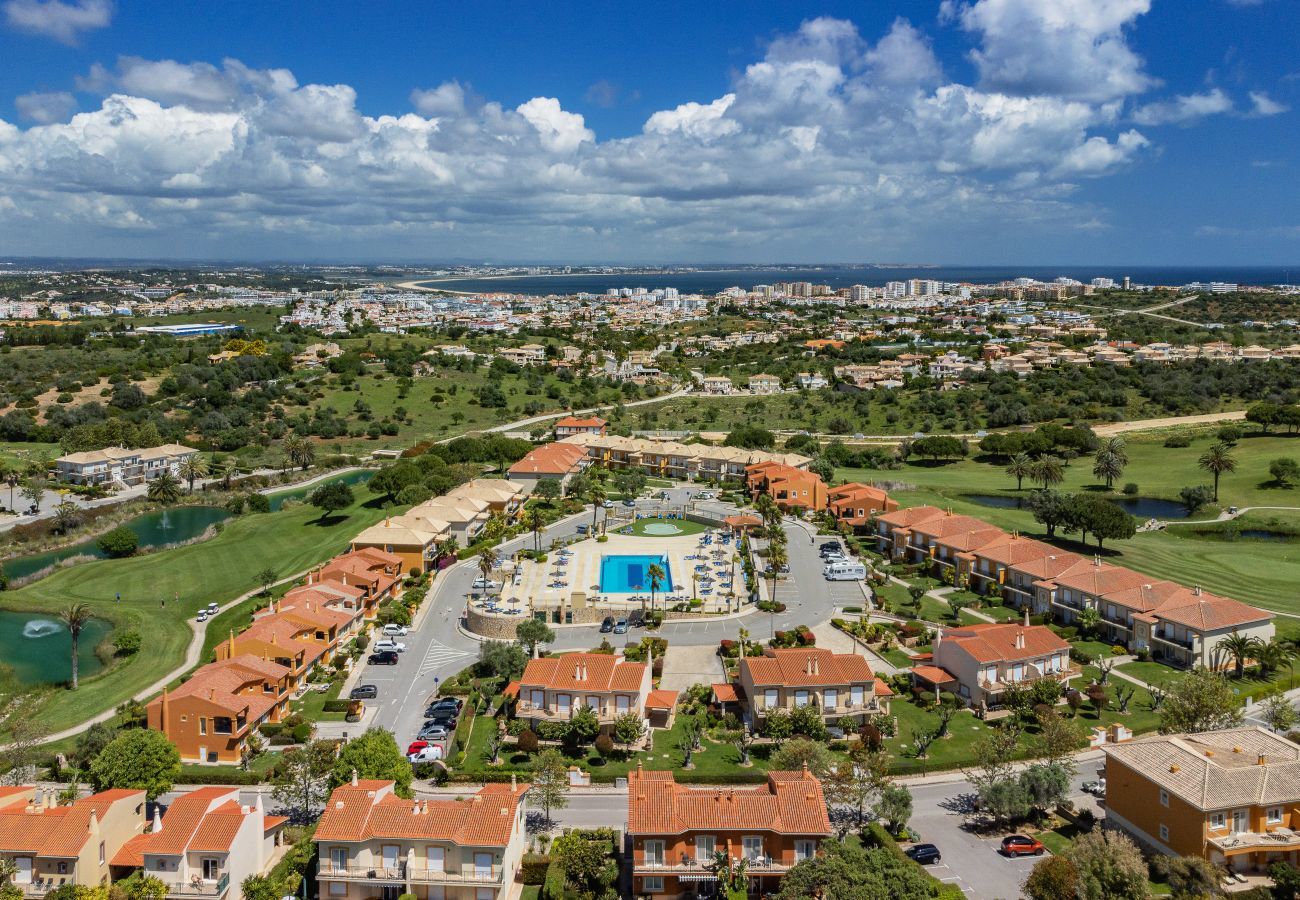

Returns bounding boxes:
[113,787,286,900]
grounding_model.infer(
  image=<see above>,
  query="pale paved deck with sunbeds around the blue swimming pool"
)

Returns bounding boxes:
[502,533,745,611]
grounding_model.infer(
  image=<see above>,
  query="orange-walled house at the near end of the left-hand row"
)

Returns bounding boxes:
[147,655,291,763]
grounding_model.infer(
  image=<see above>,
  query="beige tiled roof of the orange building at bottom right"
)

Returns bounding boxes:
[1102,728,1300,810]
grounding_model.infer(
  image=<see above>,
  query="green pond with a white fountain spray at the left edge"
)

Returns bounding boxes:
[0,610,113,684]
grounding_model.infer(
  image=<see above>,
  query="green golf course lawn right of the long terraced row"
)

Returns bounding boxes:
[836,430,1300,614]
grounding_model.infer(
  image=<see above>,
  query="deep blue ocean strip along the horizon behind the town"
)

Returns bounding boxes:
[420,263,1300,295]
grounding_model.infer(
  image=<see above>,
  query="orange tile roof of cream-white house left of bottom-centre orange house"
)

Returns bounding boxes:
[316,782,532,847]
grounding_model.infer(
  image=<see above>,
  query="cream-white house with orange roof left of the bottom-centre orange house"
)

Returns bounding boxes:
[315,775,530,900]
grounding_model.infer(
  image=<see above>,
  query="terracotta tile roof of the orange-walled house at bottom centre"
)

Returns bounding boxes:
[628,766,831,835]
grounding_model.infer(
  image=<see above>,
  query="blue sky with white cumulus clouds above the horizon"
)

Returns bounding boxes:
[0,0,1300,264]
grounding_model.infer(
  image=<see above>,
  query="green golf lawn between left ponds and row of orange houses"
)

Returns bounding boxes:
[0,492,384,731]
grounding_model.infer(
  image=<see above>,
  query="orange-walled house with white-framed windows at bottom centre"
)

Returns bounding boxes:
[628,765,831,899]
